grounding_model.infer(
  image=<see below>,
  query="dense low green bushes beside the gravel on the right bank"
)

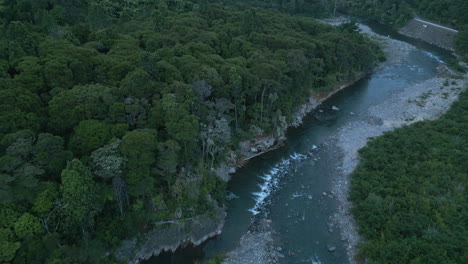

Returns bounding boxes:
[350,89,468,264]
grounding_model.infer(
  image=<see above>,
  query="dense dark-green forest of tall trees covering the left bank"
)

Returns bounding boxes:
[0,0,384,264]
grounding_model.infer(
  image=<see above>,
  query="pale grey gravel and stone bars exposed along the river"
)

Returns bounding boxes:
[224,20,467,264]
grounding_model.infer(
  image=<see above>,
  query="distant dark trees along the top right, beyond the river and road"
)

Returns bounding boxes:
[241,0,468,62]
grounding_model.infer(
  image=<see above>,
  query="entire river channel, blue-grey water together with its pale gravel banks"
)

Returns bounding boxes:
[145,22,464,264]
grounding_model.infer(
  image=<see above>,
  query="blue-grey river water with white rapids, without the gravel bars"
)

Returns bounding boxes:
[145,25,454,264]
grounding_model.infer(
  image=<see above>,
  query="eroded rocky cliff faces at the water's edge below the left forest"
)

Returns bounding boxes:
[115,73,366,264]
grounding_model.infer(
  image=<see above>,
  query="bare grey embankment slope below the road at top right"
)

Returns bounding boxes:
[398,19,457,51]
